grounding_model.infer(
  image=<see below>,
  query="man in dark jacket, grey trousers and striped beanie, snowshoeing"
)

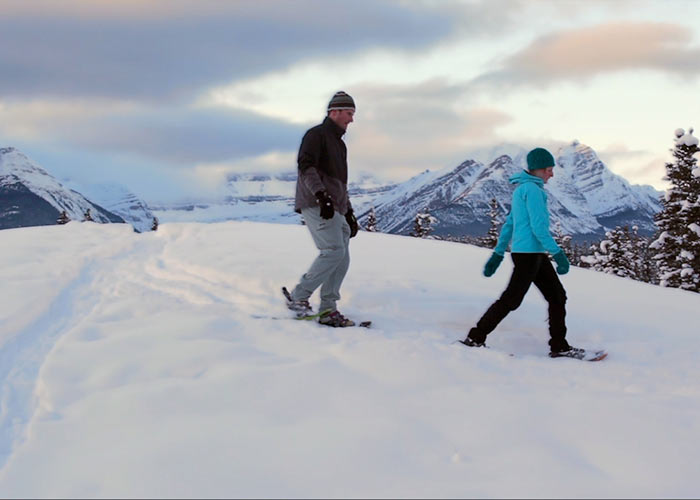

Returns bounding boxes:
[283,92,358,327]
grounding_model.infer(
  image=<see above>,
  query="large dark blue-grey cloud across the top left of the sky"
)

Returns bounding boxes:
[0,0,455,101]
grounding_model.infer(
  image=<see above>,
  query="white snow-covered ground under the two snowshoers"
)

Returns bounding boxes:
[0,222,700,498]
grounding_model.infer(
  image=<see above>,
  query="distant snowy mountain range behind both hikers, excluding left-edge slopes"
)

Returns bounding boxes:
[154,141,662,241]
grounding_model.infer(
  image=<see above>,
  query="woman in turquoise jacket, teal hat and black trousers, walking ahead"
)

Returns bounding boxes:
[460,148,585,358]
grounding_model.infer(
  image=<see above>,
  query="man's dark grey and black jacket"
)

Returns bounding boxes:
[294,117,352,215]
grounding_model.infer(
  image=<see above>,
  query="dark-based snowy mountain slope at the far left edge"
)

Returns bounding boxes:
[0,148,124,229]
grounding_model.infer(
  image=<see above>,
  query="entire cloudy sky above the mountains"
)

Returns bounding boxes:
[0,0,700,202]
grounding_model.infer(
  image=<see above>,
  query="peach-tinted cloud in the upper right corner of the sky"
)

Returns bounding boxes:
[473,23,700,85]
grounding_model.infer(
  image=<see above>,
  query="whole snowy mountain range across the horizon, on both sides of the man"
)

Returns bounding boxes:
[0,141,662,241]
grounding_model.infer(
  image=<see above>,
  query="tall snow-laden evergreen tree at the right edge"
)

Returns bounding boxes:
[651,129,700,292]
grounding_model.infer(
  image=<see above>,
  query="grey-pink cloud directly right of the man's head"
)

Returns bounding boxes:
[347,79,511,179]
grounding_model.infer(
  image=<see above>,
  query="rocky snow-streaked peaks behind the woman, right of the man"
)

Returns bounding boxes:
[360,141,661,240]
